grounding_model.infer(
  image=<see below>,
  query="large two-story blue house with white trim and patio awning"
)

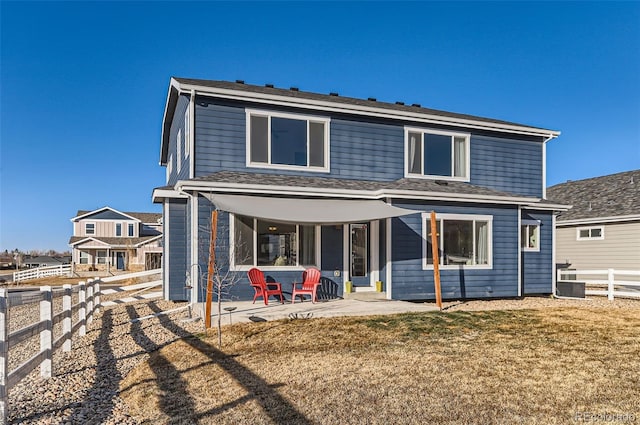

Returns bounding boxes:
[153,78,566,301]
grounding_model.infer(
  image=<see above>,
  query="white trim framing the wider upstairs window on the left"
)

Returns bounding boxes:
[245,109,331,173]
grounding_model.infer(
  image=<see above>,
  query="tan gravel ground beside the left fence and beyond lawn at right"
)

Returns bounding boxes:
[3,297,640,425]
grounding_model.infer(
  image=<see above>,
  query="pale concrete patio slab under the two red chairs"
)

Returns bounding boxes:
[194,299,438,325]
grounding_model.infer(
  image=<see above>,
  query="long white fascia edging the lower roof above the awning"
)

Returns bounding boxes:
[176,181,535,205]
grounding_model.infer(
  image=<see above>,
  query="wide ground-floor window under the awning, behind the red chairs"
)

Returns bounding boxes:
[233,215,317,267]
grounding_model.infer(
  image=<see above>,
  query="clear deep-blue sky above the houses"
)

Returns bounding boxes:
[0,1,640,251]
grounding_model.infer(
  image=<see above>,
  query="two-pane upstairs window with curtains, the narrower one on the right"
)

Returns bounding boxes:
[405,128,470,181]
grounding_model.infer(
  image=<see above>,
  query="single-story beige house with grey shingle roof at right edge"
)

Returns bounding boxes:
[547,170,640,272]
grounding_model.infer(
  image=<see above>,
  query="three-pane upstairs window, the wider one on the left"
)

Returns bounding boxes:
[247,110,330,172]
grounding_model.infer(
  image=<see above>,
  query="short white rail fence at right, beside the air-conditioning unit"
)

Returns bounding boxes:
[557,269,640,301]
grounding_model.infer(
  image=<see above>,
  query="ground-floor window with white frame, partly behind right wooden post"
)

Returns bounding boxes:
[423,213,493,268]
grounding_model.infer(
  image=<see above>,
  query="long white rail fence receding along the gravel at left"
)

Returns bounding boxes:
[0,269,162,424]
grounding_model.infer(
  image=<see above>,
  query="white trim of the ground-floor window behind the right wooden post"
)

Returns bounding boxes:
[421,212,496,270]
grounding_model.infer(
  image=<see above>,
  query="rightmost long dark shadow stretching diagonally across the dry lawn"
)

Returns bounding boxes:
[149,302,311,424]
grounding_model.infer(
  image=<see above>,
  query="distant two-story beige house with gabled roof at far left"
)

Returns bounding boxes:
[69,207,162,273]
